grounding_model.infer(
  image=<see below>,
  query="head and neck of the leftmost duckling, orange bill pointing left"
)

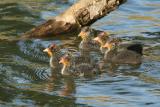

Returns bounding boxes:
[43,43,63,69]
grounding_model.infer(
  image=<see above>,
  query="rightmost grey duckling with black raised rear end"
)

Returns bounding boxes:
[103,40,143,65]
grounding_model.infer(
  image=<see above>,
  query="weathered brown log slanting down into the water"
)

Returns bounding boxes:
[23,0,126,38]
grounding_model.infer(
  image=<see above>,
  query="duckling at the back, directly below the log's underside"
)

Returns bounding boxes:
[78,26,99,50]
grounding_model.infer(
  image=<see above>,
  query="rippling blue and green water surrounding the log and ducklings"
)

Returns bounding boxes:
[0,0,160,107]
